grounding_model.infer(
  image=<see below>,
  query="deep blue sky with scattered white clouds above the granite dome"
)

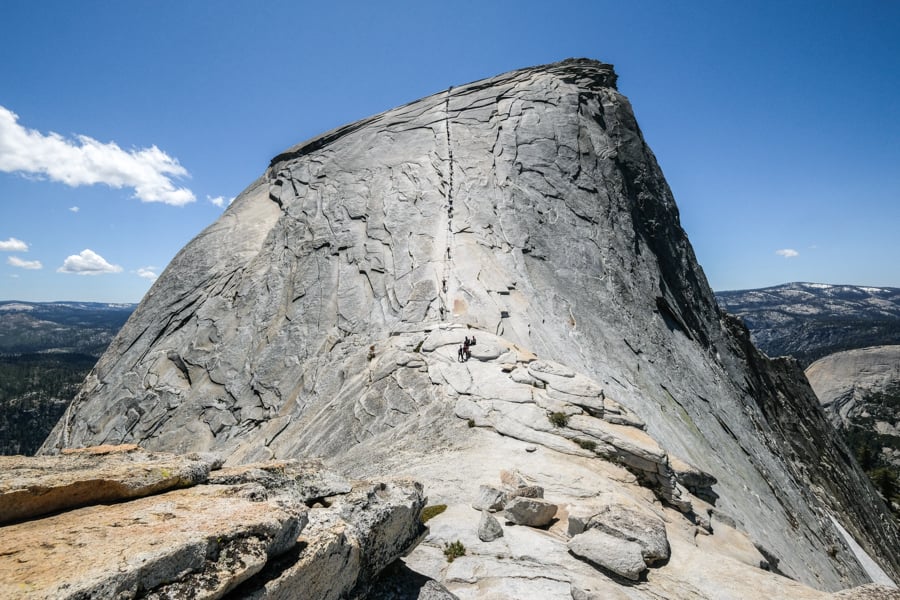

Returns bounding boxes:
[0,0,900,302]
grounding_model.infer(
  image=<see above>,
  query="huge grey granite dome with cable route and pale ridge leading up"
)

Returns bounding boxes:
[43,60,900,599]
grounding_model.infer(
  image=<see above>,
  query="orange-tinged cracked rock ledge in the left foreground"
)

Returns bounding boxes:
[0,445,425,599]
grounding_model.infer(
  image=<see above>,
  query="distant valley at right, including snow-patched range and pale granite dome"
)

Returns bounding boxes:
[716,283,900,514]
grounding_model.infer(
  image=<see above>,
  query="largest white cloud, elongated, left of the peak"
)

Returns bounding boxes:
[0,106,196,206]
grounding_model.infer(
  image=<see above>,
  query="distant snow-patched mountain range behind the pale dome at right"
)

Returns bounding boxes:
[716,283,900,367]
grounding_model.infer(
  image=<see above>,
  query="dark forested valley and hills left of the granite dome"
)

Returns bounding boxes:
[0,301,137,455]
